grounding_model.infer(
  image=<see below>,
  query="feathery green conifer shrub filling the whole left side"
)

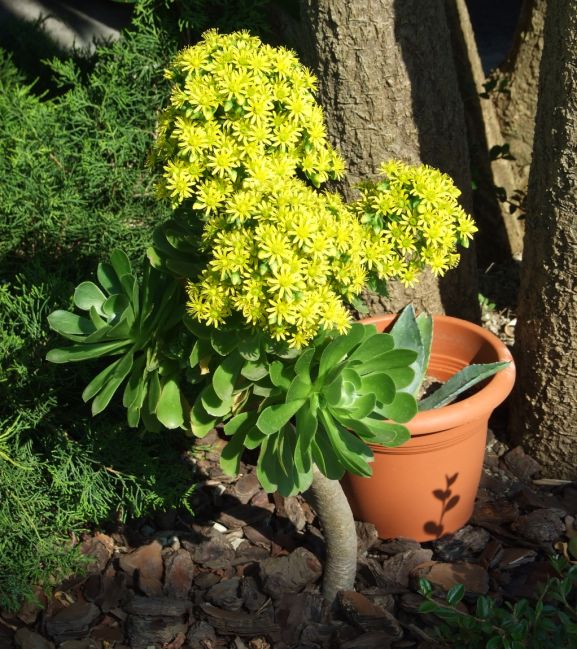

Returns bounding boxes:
[0,14,186,609]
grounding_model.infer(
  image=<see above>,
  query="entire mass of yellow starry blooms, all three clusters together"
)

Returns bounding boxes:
[154,31,476,348]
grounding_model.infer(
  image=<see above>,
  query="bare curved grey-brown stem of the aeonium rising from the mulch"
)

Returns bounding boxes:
[304,466,357,604]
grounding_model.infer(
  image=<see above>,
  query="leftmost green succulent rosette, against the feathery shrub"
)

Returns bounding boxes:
[46,250,191,431]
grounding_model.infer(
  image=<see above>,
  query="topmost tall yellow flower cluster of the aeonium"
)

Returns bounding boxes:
[153,30,344,208]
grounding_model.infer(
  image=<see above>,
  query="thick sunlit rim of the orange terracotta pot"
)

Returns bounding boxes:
[361,313,515,436]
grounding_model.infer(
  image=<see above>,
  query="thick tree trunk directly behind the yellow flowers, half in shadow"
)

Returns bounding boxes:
[298,0,478,319]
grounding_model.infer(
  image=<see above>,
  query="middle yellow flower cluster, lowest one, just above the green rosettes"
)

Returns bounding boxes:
[188,178,367,348]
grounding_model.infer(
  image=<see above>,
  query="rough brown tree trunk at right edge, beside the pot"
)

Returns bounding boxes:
[512,0,577,480]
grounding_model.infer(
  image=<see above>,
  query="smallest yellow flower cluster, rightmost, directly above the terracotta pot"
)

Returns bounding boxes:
[351,161,477,286]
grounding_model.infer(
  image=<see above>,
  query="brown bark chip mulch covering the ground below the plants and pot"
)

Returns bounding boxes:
[0,426,577,649]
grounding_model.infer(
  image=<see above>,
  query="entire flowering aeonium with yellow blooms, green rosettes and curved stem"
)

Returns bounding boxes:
[48,31,508,601]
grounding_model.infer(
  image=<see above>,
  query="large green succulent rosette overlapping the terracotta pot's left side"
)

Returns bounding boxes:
[191,323,417,496]
